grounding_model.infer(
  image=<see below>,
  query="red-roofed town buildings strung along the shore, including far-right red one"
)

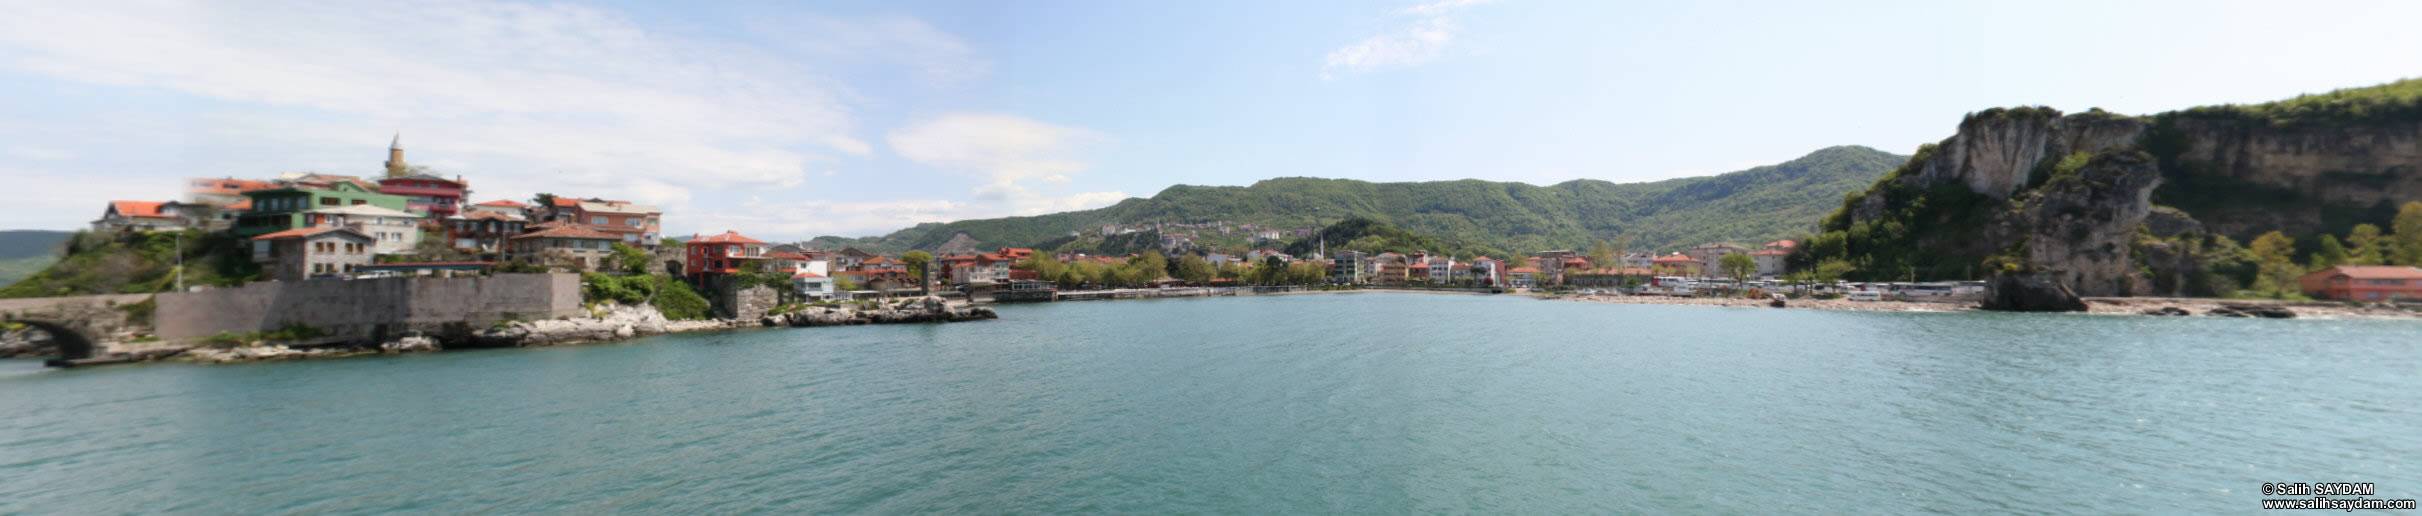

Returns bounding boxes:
[92,136,2422,310]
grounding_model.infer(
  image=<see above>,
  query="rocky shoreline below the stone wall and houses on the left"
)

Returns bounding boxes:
[175,296,1000,363]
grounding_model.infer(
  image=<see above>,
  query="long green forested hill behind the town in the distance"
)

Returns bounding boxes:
[814,145,1909,252]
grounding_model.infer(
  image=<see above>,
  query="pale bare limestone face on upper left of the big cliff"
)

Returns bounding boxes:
[1904,107,2146,199]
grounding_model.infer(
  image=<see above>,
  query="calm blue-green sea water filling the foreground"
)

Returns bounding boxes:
[0,293,2422,514]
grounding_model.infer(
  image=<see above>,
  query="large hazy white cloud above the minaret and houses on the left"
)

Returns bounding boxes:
[0,0,986,228]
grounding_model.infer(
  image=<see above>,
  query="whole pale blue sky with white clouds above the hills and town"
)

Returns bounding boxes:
[0,0,2422,240]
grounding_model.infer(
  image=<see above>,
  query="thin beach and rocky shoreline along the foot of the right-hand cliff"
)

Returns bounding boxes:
[1543,293,2422,320]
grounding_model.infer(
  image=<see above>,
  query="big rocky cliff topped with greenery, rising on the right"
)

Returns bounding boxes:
[1804,80,2422,305]
